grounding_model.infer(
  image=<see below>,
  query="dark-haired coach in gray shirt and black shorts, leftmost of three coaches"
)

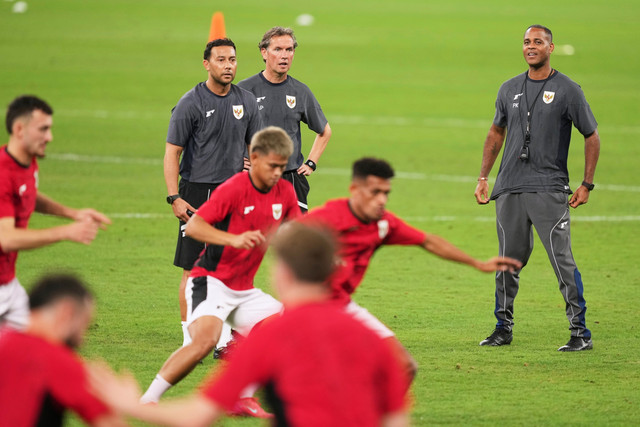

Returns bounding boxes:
[164,39,262,344]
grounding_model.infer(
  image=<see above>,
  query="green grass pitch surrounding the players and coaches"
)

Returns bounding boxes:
[0,0,640,426]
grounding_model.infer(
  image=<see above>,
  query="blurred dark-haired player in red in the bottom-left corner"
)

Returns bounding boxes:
[0,275,124,427]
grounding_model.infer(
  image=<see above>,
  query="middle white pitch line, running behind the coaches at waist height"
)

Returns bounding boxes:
[47,153,640,193]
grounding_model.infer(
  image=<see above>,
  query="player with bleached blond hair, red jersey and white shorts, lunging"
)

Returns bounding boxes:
[142,127,300,417]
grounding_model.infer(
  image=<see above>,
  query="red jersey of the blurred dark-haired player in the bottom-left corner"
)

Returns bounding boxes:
[0,328,109,426]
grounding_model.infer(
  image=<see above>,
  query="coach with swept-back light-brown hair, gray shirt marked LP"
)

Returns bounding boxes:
[238,27,331,213]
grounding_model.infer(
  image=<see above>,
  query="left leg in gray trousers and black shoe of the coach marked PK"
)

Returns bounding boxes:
[480,194,533,346]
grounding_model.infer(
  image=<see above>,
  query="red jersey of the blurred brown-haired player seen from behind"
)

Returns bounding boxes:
[202,301,406,427]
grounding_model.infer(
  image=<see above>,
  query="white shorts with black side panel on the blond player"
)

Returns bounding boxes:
[185,276,282,336]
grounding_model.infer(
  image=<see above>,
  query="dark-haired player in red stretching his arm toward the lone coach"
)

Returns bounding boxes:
[304,158,521,382]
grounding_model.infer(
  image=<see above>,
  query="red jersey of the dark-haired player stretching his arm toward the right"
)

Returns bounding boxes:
[303,199,426,303]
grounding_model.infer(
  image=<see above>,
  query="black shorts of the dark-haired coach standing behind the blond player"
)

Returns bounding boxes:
[173,179,220,270]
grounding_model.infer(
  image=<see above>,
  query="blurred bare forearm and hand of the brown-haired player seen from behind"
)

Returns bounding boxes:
[87,363,224,427]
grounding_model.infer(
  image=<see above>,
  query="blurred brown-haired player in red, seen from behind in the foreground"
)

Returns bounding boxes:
[91,222,408,427]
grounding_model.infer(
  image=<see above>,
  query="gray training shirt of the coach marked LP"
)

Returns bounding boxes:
[238,72,327,170]
